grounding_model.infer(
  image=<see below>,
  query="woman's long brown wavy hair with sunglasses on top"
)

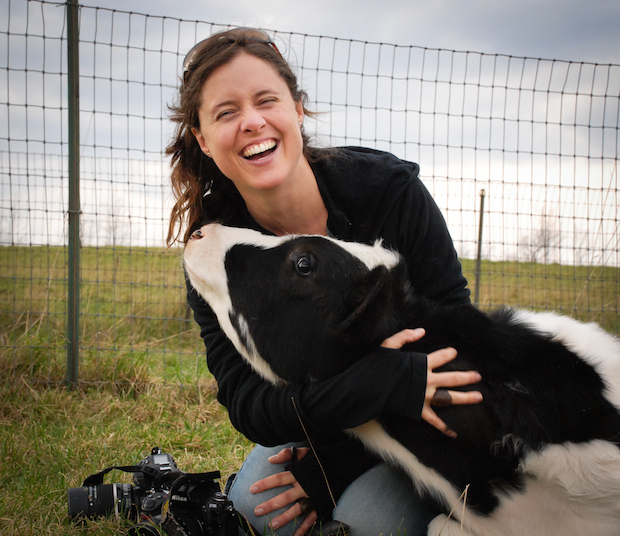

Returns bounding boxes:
[166,28,318,246]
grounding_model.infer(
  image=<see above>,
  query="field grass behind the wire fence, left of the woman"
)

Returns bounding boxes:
[0,247,208,385]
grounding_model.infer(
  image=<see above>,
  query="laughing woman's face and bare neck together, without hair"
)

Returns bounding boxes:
[192,53,320,234]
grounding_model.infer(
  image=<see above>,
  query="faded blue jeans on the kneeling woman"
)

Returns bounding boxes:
[229,443,438,536]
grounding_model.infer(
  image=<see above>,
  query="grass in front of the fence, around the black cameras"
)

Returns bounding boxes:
[0,362,252,536]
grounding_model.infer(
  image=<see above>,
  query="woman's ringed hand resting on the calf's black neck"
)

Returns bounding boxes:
[381,328,482,437]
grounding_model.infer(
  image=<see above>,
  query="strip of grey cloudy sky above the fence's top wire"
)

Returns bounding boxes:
[79,0,620,63]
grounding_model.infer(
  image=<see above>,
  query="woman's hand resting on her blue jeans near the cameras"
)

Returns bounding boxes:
[250,448,317,536]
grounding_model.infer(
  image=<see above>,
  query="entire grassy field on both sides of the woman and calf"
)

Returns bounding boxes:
[0,247,620,536]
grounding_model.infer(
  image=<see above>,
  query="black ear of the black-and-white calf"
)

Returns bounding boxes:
[338,266,389,333]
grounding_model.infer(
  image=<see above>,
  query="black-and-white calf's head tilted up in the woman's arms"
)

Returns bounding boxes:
[184,224,407,384]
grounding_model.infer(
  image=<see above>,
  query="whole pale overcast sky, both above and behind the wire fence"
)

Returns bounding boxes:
[0,0,620,266]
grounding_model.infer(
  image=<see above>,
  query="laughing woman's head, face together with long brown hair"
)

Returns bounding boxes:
[166,28,325,244]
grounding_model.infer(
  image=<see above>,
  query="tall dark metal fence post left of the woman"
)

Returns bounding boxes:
[66,0,80,389]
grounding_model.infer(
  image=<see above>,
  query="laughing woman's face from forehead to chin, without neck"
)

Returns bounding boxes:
[192,53,305,200]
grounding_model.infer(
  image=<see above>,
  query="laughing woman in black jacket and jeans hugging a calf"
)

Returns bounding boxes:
[167,28,481,536]
